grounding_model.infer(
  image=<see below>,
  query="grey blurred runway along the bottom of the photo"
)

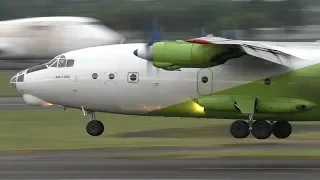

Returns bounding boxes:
[0,150,320,180]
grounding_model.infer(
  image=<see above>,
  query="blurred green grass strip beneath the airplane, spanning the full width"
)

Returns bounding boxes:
[0,109,320,158]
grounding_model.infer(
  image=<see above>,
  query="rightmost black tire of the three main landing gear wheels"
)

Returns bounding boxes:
[272,121,292,139]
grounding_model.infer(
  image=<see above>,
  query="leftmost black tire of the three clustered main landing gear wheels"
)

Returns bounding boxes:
[230,120,250,139]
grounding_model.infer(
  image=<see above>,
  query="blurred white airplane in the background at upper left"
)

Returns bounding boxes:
[0,16,125,60]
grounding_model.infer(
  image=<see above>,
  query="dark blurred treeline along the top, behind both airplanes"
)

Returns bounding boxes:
[0,0,315,32]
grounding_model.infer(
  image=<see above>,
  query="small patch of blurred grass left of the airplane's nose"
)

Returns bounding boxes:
[0,73,20,97]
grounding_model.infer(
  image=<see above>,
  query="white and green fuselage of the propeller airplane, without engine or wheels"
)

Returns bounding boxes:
[11,38,320,139]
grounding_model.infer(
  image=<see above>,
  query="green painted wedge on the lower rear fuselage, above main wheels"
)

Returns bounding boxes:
[150,64,320,121]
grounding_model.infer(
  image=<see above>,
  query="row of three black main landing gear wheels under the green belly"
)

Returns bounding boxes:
[230,118,292,139]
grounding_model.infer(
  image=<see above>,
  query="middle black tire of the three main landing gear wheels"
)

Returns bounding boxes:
[251,120,272,139]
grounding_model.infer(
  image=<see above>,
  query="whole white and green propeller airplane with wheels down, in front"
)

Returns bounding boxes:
[10,32,320,139]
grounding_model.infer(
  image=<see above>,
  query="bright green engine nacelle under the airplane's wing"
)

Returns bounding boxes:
[153,41,238,70]
